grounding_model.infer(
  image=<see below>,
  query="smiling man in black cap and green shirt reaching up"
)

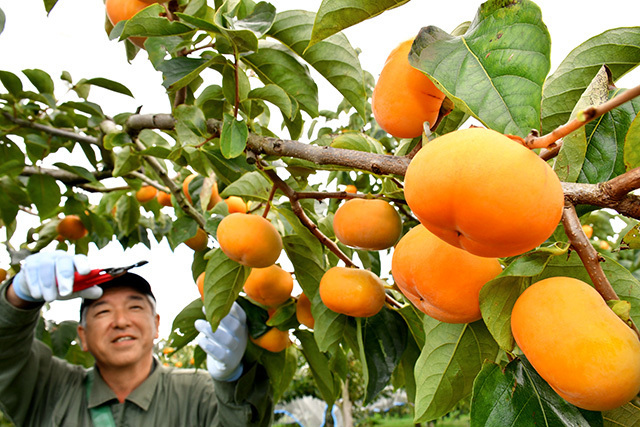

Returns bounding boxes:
[0,251,273,427]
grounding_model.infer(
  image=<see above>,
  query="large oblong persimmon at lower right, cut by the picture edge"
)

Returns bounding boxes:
[511,277,640,411]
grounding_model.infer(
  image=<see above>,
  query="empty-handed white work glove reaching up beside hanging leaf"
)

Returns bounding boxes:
[194,302,248,381]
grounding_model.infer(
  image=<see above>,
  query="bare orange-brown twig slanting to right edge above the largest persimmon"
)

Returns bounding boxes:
[524,85,640,148]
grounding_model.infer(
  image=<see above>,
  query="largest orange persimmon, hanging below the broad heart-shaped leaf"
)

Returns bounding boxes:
[404,128,564,257]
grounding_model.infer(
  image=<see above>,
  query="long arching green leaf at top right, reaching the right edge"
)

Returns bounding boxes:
[541,27,640,133]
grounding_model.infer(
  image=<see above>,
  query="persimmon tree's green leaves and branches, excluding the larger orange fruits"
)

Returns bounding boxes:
[0,0,640,426]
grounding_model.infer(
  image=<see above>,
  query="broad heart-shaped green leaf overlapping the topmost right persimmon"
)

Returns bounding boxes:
[409,0,551,137]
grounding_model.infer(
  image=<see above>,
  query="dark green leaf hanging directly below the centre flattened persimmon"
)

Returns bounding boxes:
[358,308,407,405]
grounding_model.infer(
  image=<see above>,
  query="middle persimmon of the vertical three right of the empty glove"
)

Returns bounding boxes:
[244,264,293,307]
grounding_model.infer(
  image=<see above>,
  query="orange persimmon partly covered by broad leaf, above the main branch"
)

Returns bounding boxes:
[371,39,445,138]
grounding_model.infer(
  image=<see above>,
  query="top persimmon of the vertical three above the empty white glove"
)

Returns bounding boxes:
[216,212,282,268]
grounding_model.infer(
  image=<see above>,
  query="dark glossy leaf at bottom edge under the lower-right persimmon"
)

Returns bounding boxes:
[471,357,602,427]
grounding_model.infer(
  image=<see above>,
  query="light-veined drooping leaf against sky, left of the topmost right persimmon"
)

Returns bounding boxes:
[269,10,367,117]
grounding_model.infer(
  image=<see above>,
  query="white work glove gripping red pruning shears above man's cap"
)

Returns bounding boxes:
[13,250,102,302]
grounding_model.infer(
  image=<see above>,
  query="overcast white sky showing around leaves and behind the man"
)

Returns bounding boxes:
[0,0,640,337]
